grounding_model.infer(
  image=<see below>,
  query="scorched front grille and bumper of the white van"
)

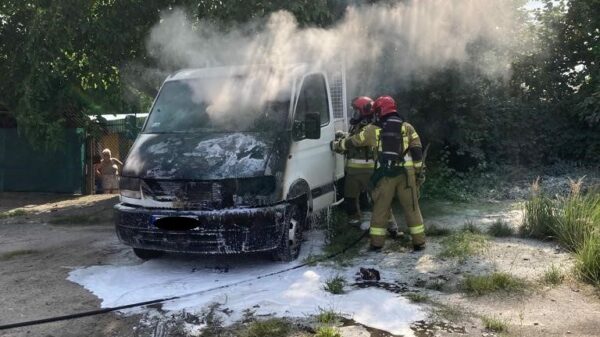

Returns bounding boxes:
[116,177,287,254]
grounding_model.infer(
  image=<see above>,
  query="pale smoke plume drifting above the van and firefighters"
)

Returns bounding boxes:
[147,0,515,129]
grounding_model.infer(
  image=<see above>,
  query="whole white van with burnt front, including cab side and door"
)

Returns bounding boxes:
[115,65,347,260]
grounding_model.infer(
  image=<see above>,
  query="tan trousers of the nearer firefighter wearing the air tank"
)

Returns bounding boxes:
[370,168,425,247]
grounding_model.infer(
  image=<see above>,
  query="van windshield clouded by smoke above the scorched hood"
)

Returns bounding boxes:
[143,77,290,133]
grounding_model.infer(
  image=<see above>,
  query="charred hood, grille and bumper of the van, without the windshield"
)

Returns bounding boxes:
[115,132,290,254]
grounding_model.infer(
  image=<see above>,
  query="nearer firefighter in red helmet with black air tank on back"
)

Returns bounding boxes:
[333,96,425,251]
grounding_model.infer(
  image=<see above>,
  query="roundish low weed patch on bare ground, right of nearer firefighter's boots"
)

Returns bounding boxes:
[438,231,487,261]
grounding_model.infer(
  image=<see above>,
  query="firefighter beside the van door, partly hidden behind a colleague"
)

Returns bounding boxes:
[334,96,399,236]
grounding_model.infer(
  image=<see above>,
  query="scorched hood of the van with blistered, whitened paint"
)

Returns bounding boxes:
[122,133,287,180]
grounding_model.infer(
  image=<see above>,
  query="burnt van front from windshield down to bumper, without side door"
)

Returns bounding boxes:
[115,67,298,259]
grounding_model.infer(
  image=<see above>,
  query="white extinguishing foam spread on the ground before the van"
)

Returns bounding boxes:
[68,233,425,336]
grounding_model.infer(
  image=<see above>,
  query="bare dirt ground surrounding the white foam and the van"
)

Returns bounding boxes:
[0,194,600,337]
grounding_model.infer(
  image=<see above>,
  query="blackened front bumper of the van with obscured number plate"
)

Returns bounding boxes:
[115,203,287,254]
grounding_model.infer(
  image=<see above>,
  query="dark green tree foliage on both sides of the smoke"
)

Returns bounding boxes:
[0,0,600,165]
